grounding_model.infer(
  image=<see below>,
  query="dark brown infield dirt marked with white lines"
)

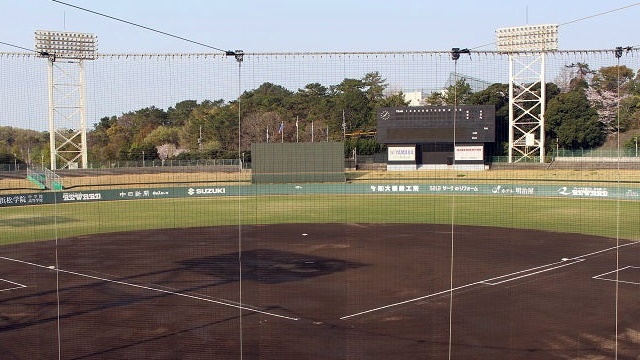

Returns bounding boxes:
[0,224,640,360]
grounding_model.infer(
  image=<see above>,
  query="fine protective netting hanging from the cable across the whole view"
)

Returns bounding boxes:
[0,48,640,359]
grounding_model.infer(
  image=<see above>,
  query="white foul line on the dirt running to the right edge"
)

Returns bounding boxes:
[340,242,639,320]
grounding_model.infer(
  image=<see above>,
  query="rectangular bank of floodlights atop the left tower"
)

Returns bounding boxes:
[36,30,98,60]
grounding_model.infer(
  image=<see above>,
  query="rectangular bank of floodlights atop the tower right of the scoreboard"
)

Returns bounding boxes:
[496,24,558,52]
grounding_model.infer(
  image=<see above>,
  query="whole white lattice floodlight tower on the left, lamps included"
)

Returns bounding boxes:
[36,30,97,170]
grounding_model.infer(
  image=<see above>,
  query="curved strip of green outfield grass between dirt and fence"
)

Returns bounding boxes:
[0,195,640,244]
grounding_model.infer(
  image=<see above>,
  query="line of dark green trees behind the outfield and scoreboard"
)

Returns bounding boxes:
[0,63,640,169]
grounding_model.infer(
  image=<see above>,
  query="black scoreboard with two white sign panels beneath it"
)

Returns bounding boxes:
[376,105,495,170]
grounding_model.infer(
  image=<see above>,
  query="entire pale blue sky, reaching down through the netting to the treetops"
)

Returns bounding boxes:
[0,0,640,130]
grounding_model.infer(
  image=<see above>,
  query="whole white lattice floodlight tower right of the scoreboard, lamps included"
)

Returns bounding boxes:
[496,25,558,163]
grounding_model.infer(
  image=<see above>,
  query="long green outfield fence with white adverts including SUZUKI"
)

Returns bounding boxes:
[0,182,640,208]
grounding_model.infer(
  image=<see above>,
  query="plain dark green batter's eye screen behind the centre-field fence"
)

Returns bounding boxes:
[251,142,345,184]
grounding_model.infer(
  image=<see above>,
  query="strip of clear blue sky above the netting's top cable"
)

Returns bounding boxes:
[0,0,640,54]
